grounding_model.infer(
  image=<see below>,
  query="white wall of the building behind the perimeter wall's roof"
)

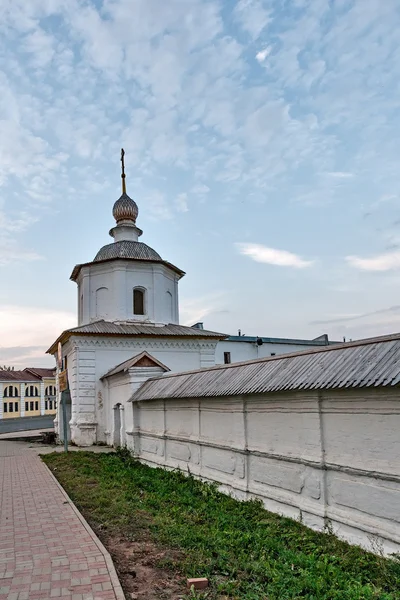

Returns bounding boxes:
[215,340,320,365]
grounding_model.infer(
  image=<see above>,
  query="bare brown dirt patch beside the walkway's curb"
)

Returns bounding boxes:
[102,534,187,600]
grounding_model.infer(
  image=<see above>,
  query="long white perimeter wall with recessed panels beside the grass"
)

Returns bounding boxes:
[125,388,400,552]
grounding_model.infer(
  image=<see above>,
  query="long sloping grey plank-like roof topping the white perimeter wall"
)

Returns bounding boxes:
[133,334,400,400]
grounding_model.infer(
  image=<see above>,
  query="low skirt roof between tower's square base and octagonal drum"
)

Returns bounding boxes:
[47,320,226,354]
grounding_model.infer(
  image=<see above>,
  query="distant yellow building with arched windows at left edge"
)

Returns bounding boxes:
[0,368,57,419]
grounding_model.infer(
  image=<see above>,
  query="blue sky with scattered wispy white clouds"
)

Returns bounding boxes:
[0,0,400,367]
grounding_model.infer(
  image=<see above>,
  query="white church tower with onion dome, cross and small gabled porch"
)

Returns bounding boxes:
[47,150,227,446]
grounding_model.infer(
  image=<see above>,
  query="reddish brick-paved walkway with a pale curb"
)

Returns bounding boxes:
[0,441,125,600]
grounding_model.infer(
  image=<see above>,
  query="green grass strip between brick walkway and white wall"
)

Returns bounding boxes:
[42,452,400,600]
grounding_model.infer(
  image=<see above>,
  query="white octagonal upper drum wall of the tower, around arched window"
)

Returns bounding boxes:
[78,260,179,325]
